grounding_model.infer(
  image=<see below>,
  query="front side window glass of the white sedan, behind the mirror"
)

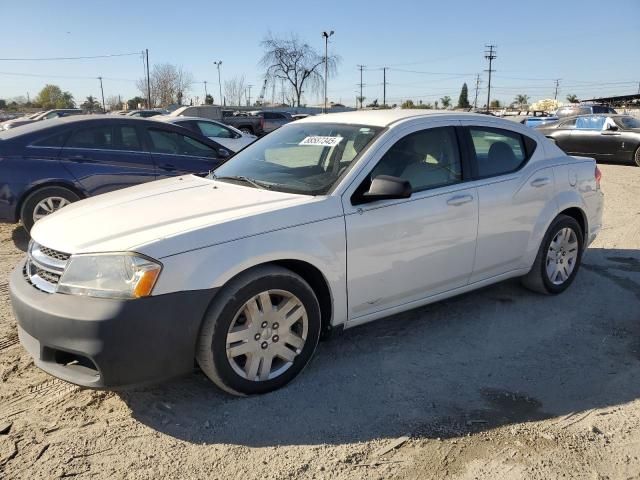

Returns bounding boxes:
[371,127,462,192]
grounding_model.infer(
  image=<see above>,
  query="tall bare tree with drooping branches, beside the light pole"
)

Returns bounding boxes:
[260,33,339,107]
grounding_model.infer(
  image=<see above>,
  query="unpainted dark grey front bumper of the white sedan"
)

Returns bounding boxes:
[9,261,215,388]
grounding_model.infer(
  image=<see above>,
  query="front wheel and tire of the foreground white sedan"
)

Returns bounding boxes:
[196,265,321,395]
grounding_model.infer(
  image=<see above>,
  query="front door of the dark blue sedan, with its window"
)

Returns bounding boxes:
[146,127,222,178]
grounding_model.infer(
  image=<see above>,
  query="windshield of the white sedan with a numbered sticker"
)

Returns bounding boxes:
[209,123,381,195]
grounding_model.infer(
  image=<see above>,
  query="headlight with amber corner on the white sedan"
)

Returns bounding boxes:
[57,253,162,298]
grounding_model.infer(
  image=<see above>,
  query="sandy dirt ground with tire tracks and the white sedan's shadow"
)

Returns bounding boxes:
[0,165,640,479]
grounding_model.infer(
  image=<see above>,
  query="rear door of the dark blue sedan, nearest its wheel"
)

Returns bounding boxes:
[59,122,156,195]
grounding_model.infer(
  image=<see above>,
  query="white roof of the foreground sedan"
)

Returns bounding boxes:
[296,109,488,127]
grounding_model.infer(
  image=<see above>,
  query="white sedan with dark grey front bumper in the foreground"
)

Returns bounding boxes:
[10,110,603,394]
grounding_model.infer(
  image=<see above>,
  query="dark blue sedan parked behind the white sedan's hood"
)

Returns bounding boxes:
[0,115,230,230]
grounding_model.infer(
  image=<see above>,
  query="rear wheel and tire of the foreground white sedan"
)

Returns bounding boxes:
[522,215,584,295]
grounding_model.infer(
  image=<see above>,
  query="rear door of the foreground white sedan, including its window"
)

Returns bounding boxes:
[462,120,554,283]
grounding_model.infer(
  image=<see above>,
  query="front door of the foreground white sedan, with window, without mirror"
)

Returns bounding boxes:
[343,122,478,323]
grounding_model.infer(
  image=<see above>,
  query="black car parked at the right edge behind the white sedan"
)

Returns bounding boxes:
[537,115,640,166]
